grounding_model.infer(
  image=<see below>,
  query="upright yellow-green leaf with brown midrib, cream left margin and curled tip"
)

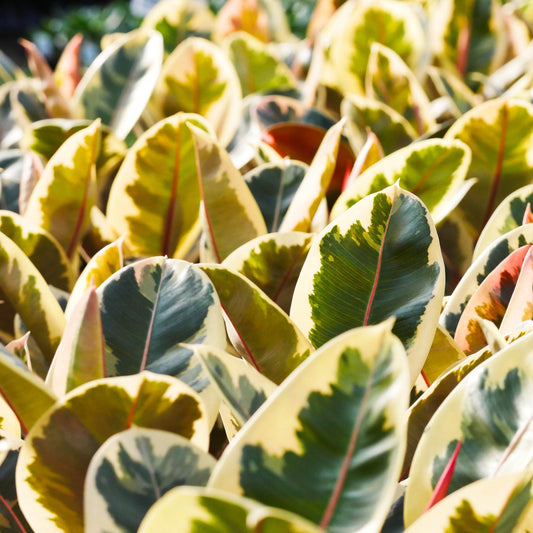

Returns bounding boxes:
[107,113,210,258]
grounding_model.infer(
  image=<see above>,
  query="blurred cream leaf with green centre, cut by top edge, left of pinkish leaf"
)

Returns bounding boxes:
[141,0,215,54]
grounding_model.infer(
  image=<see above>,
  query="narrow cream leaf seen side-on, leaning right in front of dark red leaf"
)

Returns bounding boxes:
[279,120,344,231]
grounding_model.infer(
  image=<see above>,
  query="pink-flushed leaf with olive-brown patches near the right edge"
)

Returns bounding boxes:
[454,245,533,354]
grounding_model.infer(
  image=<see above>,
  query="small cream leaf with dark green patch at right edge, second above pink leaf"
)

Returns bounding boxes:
[473,185,533,260]
